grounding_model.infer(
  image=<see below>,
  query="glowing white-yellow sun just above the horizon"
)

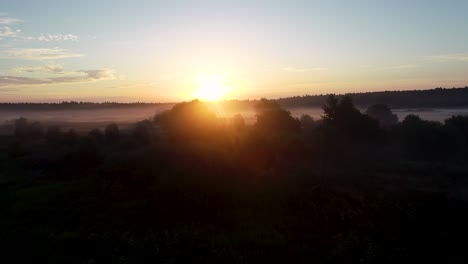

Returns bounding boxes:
[193,74,230,101]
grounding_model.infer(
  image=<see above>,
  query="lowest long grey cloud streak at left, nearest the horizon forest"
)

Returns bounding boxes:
[0,69,116,86]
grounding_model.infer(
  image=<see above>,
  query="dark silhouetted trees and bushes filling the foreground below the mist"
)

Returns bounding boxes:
[0,96,468,263]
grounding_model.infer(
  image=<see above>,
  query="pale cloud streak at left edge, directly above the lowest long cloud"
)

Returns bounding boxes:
[1,48,83,60]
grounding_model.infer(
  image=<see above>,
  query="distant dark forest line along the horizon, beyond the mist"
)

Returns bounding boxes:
[0,86,468,111]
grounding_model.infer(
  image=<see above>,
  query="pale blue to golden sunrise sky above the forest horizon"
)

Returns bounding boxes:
[0,0,468,102]
